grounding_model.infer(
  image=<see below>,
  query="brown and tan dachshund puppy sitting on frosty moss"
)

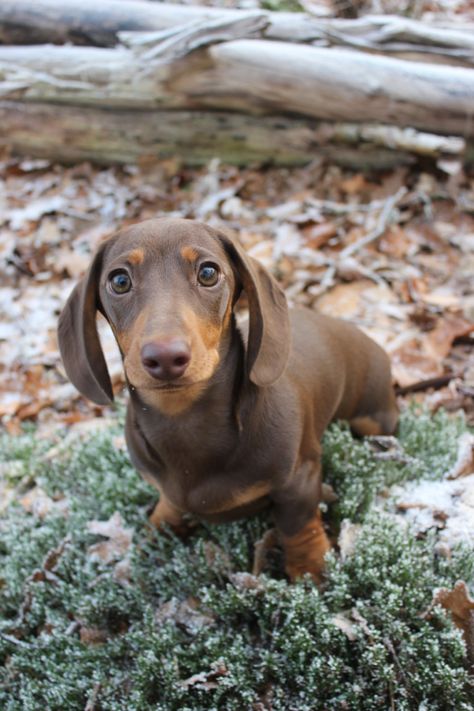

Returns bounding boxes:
[59,219,398,582]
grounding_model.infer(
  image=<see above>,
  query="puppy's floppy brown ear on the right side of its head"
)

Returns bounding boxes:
[214,233,290,386]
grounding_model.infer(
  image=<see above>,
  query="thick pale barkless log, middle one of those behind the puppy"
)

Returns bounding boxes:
[0,40,474,137]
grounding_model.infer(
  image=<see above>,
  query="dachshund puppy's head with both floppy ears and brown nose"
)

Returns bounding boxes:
[58,219,289,411]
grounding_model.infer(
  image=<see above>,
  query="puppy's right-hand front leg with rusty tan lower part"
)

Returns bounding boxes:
[272,459,331,585]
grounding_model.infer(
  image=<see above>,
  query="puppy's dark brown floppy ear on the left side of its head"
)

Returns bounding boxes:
[58,242,114,405]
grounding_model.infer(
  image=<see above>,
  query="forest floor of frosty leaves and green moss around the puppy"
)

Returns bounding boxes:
[0,0,474,700]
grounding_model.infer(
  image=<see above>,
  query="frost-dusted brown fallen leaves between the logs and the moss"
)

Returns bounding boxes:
[0,159,474,432]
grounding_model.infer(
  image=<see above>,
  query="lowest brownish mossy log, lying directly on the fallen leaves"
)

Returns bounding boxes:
[0,101,465,170]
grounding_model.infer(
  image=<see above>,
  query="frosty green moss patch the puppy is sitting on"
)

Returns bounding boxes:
[0,411,474,711]
